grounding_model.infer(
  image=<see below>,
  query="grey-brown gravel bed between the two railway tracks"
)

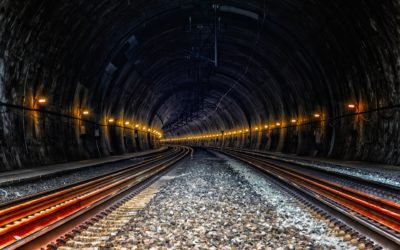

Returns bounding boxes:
[103,150,352,249]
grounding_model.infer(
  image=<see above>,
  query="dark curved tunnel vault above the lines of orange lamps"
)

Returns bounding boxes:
[0,0,400,162]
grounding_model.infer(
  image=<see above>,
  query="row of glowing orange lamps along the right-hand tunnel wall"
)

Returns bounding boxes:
[162,104,358,142]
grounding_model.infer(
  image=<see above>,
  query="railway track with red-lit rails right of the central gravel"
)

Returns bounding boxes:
[214,148,400,249]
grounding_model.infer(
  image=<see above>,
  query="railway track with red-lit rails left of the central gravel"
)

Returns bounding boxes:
[0,147,192,249]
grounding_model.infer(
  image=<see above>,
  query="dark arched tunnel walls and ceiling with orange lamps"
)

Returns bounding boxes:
[0,0,400,246]
